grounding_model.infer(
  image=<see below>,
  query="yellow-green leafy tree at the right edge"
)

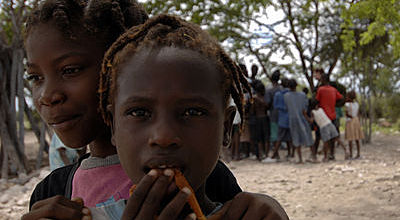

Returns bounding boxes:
[341,0,400,142]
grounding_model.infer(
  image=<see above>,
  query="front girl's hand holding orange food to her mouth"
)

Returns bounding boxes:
[121,169,196,220]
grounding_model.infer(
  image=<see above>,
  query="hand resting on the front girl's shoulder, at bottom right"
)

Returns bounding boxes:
[208,192,289,220]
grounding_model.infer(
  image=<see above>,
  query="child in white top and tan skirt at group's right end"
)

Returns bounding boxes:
[345,90,364,158]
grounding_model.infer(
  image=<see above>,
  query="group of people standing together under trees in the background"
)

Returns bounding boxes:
[227,65,364,163]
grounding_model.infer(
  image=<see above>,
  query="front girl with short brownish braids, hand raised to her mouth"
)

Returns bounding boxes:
[94,15,288,220]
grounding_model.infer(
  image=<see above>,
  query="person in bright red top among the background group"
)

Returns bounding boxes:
[315,74,343,160]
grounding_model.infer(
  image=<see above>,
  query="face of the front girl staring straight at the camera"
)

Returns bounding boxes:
[109,47,235,190]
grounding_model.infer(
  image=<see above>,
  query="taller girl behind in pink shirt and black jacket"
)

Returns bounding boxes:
[23,0,241,220]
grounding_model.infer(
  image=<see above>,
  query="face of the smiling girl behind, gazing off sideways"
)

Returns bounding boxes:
[26,22,106,147]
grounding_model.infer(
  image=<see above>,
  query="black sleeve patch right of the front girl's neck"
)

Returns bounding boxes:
[206,160,242,203]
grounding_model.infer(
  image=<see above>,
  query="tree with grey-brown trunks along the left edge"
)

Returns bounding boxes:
[0,0,48,178]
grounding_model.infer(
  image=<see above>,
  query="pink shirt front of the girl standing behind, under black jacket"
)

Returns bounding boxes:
[71,163,132,207]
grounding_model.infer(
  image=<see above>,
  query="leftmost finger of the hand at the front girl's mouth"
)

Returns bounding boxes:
[121,169,158,220]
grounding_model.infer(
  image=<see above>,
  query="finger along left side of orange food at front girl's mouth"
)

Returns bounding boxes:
[136,169,174,219]
